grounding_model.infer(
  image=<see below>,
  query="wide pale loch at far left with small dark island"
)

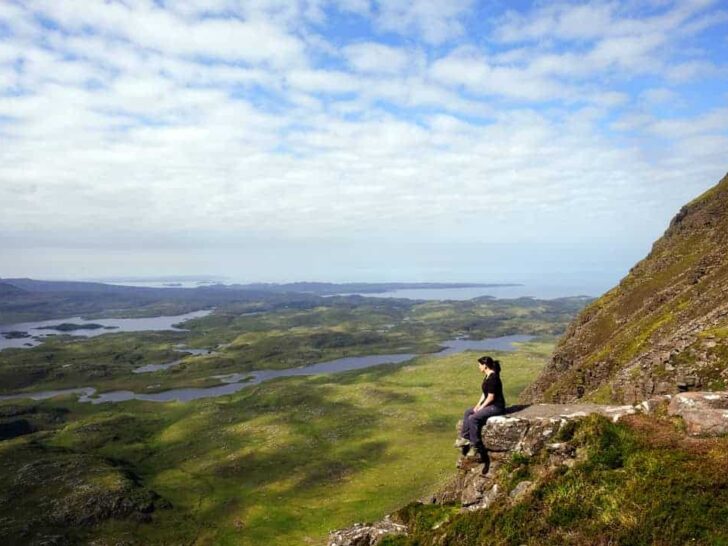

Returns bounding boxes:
[0,310,212,351]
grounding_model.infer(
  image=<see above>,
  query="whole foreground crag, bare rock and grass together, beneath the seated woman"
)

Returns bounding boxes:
[328,392,728,546]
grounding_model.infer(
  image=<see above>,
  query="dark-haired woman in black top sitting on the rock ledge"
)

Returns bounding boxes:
[455,356,506,461]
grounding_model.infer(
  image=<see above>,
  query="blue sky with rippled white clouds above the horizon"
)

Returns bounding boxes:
[0,0,728,285]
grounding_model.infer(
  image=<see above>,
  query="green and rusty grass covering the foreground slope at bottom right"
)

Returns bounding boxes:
[381,415,728,546]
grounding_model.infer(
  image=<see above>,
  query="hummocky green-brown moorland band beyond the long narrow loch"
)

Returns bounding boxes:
[0,296,585,394]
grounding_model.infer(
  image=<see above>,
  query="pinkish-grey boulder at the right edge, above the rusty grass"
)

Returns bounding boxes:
[667,392,728,436]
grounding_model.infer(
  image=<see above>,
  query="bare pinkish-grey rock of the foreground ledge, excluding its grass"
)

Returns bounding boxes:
[328,392,728,546]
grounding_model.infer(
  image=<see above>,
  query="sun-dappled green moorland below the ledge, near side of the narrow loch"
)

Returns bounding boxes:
[0,342,553,545]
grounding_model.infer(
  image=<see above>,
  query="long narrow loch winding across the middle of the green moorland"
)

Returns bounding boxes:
[0,335,534,404]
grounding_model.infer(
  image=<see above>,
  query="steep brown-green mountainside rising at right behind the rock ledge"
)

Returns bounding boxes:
[522,172,728,402]
